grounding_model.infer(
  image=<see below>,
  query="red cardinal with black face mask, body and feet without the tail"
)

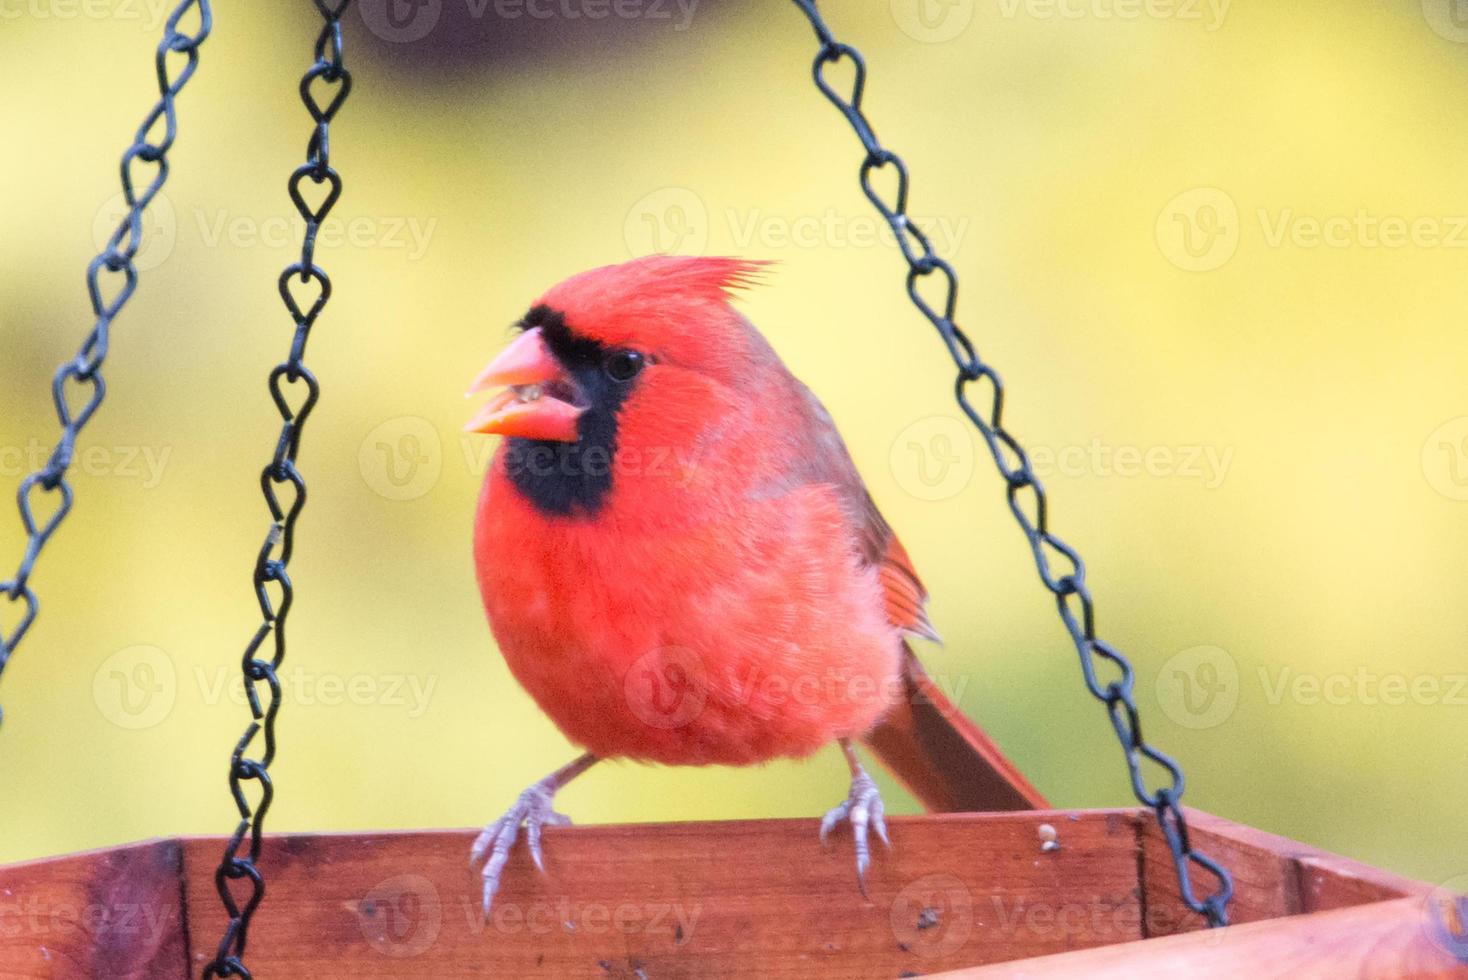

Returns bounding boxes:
[467,255,937,913]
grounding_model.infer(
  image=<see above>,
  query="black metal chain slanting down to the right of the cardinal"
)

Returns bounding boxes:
[794,0,1233,926]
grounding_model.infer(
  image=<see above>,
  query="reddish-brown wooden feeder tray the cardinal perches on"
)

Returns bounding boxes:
[0,810,1468,980]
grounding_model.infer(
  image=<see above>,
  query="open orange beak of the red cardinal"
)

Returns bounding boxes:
[464,327,583,443]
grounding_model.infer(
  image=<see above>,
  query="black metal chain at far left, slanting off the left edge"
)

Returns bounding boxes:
[0,0,214,718]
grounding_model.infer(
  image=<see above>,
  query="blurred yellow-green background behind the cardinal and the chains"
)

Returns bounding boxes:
[0,0,1468,897]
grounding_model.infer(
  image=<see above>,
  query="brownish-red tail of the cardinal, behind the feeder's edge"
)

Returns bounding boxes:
[866,643,1048,813]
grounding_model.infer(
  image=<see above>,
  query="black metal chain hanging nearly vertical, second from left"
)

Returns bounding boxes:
[204,0,352,977]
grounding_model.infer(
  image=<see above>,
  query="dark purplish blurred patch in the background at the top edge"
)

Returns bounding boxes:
[348,0,731,85]
